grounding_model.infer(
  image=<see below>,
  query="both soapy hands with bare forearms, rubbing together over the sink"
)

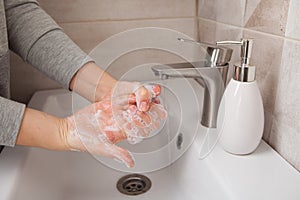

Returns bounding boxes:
[17,58,167,167]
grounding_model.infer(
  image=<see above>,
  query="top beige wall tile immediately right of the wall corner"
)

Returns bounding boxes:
[198,0,246,26]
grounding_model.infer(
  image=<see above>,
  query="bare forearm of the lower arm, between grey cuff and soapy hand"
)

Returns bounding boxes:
[16,108,70,150]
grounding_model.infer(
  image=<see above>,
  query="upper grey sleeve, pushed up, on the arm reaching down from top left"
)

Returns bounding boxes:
[4,0,92,88]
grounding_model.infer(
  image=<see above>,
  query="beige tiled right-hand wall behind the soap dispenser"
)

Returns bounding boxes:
[198,0,300,170]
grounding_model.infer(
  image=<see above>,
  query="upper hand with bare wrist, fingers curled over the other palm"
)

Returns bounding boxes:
[70,62,160,111]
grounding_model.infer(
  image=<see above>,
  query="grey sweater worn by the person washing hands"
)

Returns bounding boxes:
[0,0,90,146]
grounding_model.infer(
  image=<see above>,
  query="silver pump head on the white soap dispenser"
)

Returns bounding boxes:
[217,39,255,82]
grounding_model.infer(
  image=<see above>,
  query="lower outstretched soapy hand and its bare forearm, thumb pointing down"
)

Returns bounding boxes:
[17,86,167,167]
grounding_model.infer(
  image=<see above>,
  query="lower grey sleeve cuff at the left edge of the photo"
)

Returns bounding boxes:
[0,96,25,146]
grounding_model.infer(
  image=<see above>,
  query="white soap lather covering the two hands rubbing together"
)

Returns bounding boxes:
[66,81,167,167]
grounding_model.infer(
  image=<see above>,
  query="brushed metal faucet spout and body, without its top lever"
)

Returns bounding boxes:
[152,61,229,128]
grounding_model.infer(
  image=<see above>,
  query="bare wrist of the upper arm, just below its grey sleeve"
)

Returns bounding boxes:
[70,62,117,102]
